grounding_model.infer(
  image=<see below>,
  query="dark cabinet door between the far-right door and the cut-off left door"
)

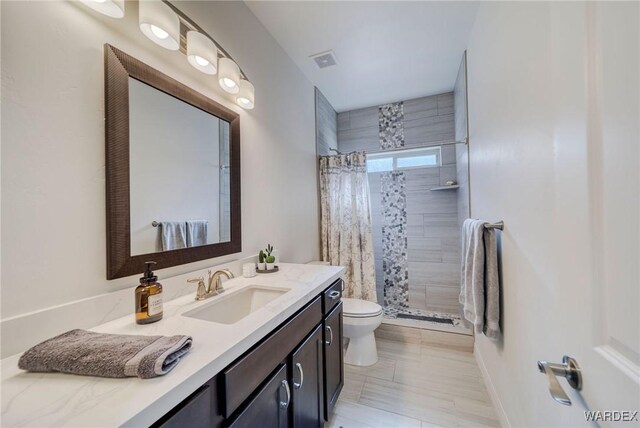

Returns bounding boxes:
[291,325,324,428]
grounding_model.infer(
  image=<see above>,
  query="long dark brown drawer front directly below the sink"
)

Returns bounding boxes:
[220,296,322,417]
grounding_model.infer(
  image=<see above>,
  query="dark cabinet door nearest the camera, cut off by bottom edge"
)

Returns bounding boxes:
[229,364,291,428]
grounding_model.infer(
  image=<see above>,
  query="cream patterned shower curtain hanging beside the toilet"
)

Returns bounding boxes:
[320,152,377,302]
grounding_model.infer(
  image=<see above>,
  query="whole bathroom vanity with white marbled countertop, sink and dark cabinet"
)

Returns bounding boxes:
[1,263,344,427]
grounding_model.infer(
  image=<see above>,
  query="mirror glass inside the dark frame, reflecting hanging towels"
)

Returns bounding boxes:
[129,77,231,256]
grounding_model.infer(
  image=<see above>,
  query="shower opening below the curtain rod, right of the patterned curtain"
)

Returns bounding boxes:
[367,143,469,333]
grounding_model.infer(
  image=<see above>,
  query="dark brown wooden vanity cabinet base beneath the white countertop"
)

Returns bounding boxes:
[153,280,344,428]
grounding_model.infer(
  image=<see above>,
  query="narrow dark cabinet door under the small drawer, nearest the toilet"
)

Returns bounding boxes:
[323,302,344,421]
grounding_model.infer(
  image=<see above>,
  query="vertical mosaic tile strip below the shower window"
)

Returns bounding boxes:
[380,171,409,308]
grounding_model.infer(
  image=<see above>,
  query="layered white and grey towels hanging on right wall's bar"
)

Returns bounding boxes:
[459,219,500,340]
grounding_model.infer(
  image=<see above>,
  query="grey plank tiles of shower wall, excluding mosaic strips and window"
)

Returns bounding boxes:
[338,93,466,313]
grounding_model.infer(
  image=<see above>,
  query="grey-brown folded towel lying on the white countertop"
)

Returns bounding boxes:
[18,329,192,379]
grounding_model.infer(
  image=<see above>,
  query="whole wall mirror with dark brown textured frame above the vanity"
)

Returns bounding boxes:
[104,44,242,279]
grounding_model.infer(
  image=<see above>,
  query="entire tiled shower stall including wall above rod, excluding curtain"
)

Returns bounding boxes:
[337,92,471,334]
